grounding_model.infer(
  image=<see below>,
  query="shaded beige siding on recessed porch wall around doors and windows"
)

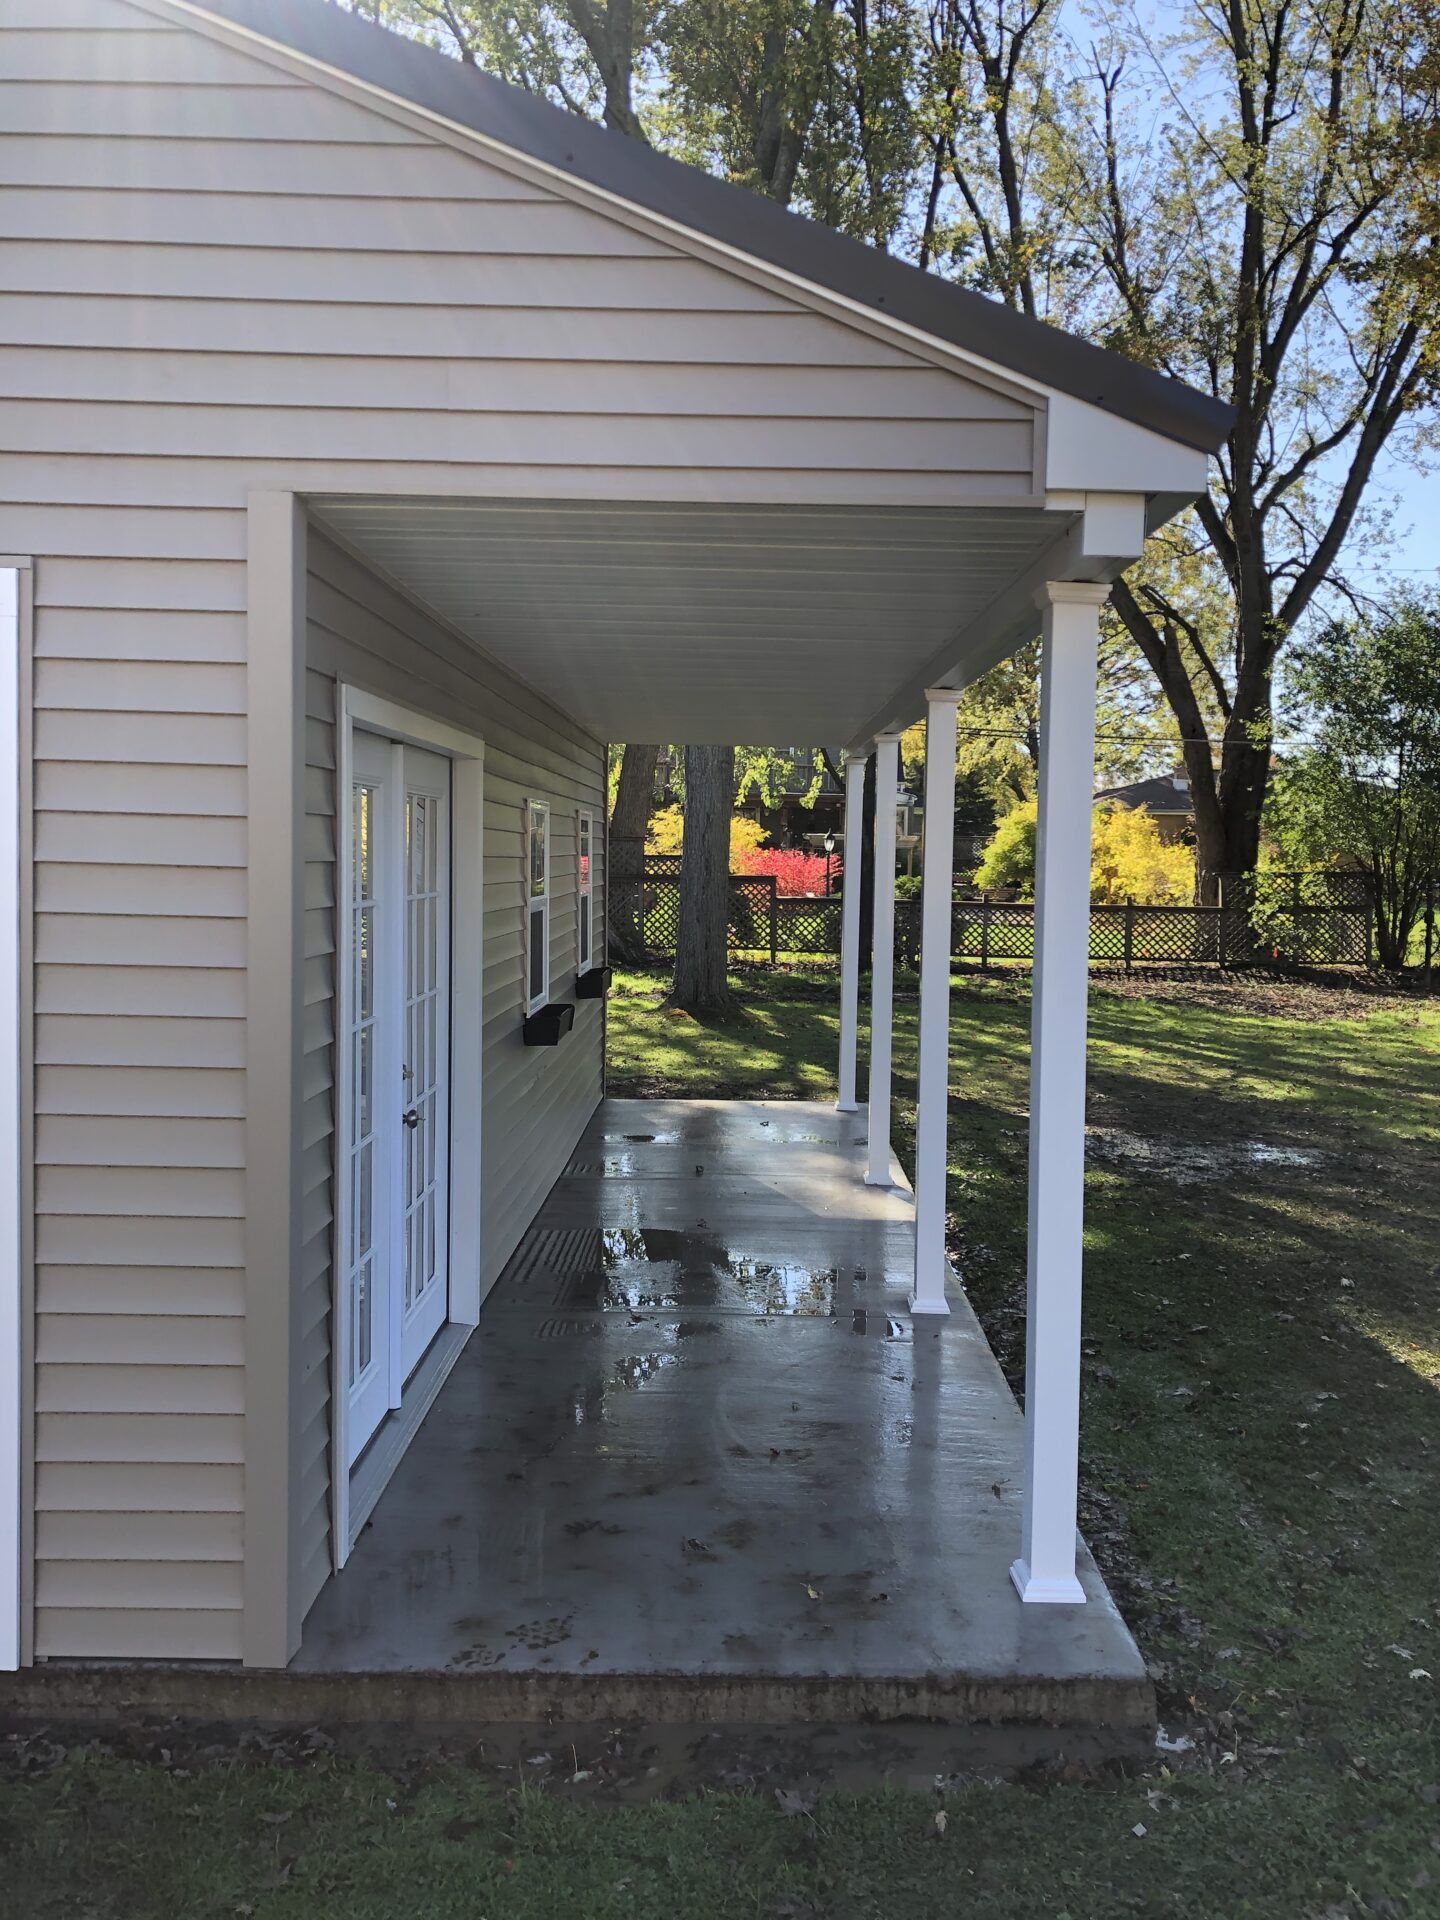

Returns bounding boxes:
[307,526,605,1605]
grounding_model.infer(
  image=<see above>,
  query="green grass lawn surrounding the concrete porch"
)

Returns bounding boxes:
[0,972,1440,1920]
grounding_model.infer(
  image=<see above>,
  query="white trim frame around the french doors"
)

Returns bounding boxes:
[330,682,486,1572]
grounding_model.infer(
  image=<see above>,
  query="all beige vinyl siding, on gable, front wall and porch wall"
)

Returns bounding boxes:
[0,0,1035,1659]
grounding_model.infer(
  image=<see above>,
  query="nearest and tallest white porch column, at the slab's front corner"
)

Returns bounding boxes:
[1010,582,1110,1603]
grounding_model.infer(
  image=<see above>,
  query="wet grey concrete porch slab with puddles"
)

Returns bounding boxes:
[299,1100,1152,1732]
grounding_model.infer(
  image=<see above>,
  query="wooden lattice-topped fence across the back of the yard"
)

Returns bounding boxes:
[611,864,1373,972]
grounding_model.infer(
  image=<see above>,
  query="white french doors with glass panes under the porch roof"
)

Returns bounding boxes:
[340,730,451,1467]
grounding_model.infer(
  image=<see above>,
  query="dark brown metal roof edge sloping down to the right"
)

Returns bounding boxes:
[171,0,1235,453]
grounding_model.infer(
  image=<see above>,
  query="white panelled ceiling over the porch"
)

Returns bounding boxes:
[311,497,1068,745]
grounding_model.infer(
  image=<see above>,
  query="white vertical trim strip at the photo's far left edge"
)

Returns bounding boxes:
[0,559,31,1672]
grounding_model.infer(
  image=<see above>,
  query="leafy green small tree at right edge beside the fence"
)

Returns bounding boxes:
[1269,593,1440,968]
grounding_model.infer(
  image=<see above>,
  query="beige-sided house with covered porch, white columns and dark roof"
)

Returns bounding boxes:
[0,0,1227,1712]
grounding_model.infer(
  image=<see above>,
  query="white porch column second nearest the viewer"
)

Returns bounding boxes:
[910,687,960,1313]
